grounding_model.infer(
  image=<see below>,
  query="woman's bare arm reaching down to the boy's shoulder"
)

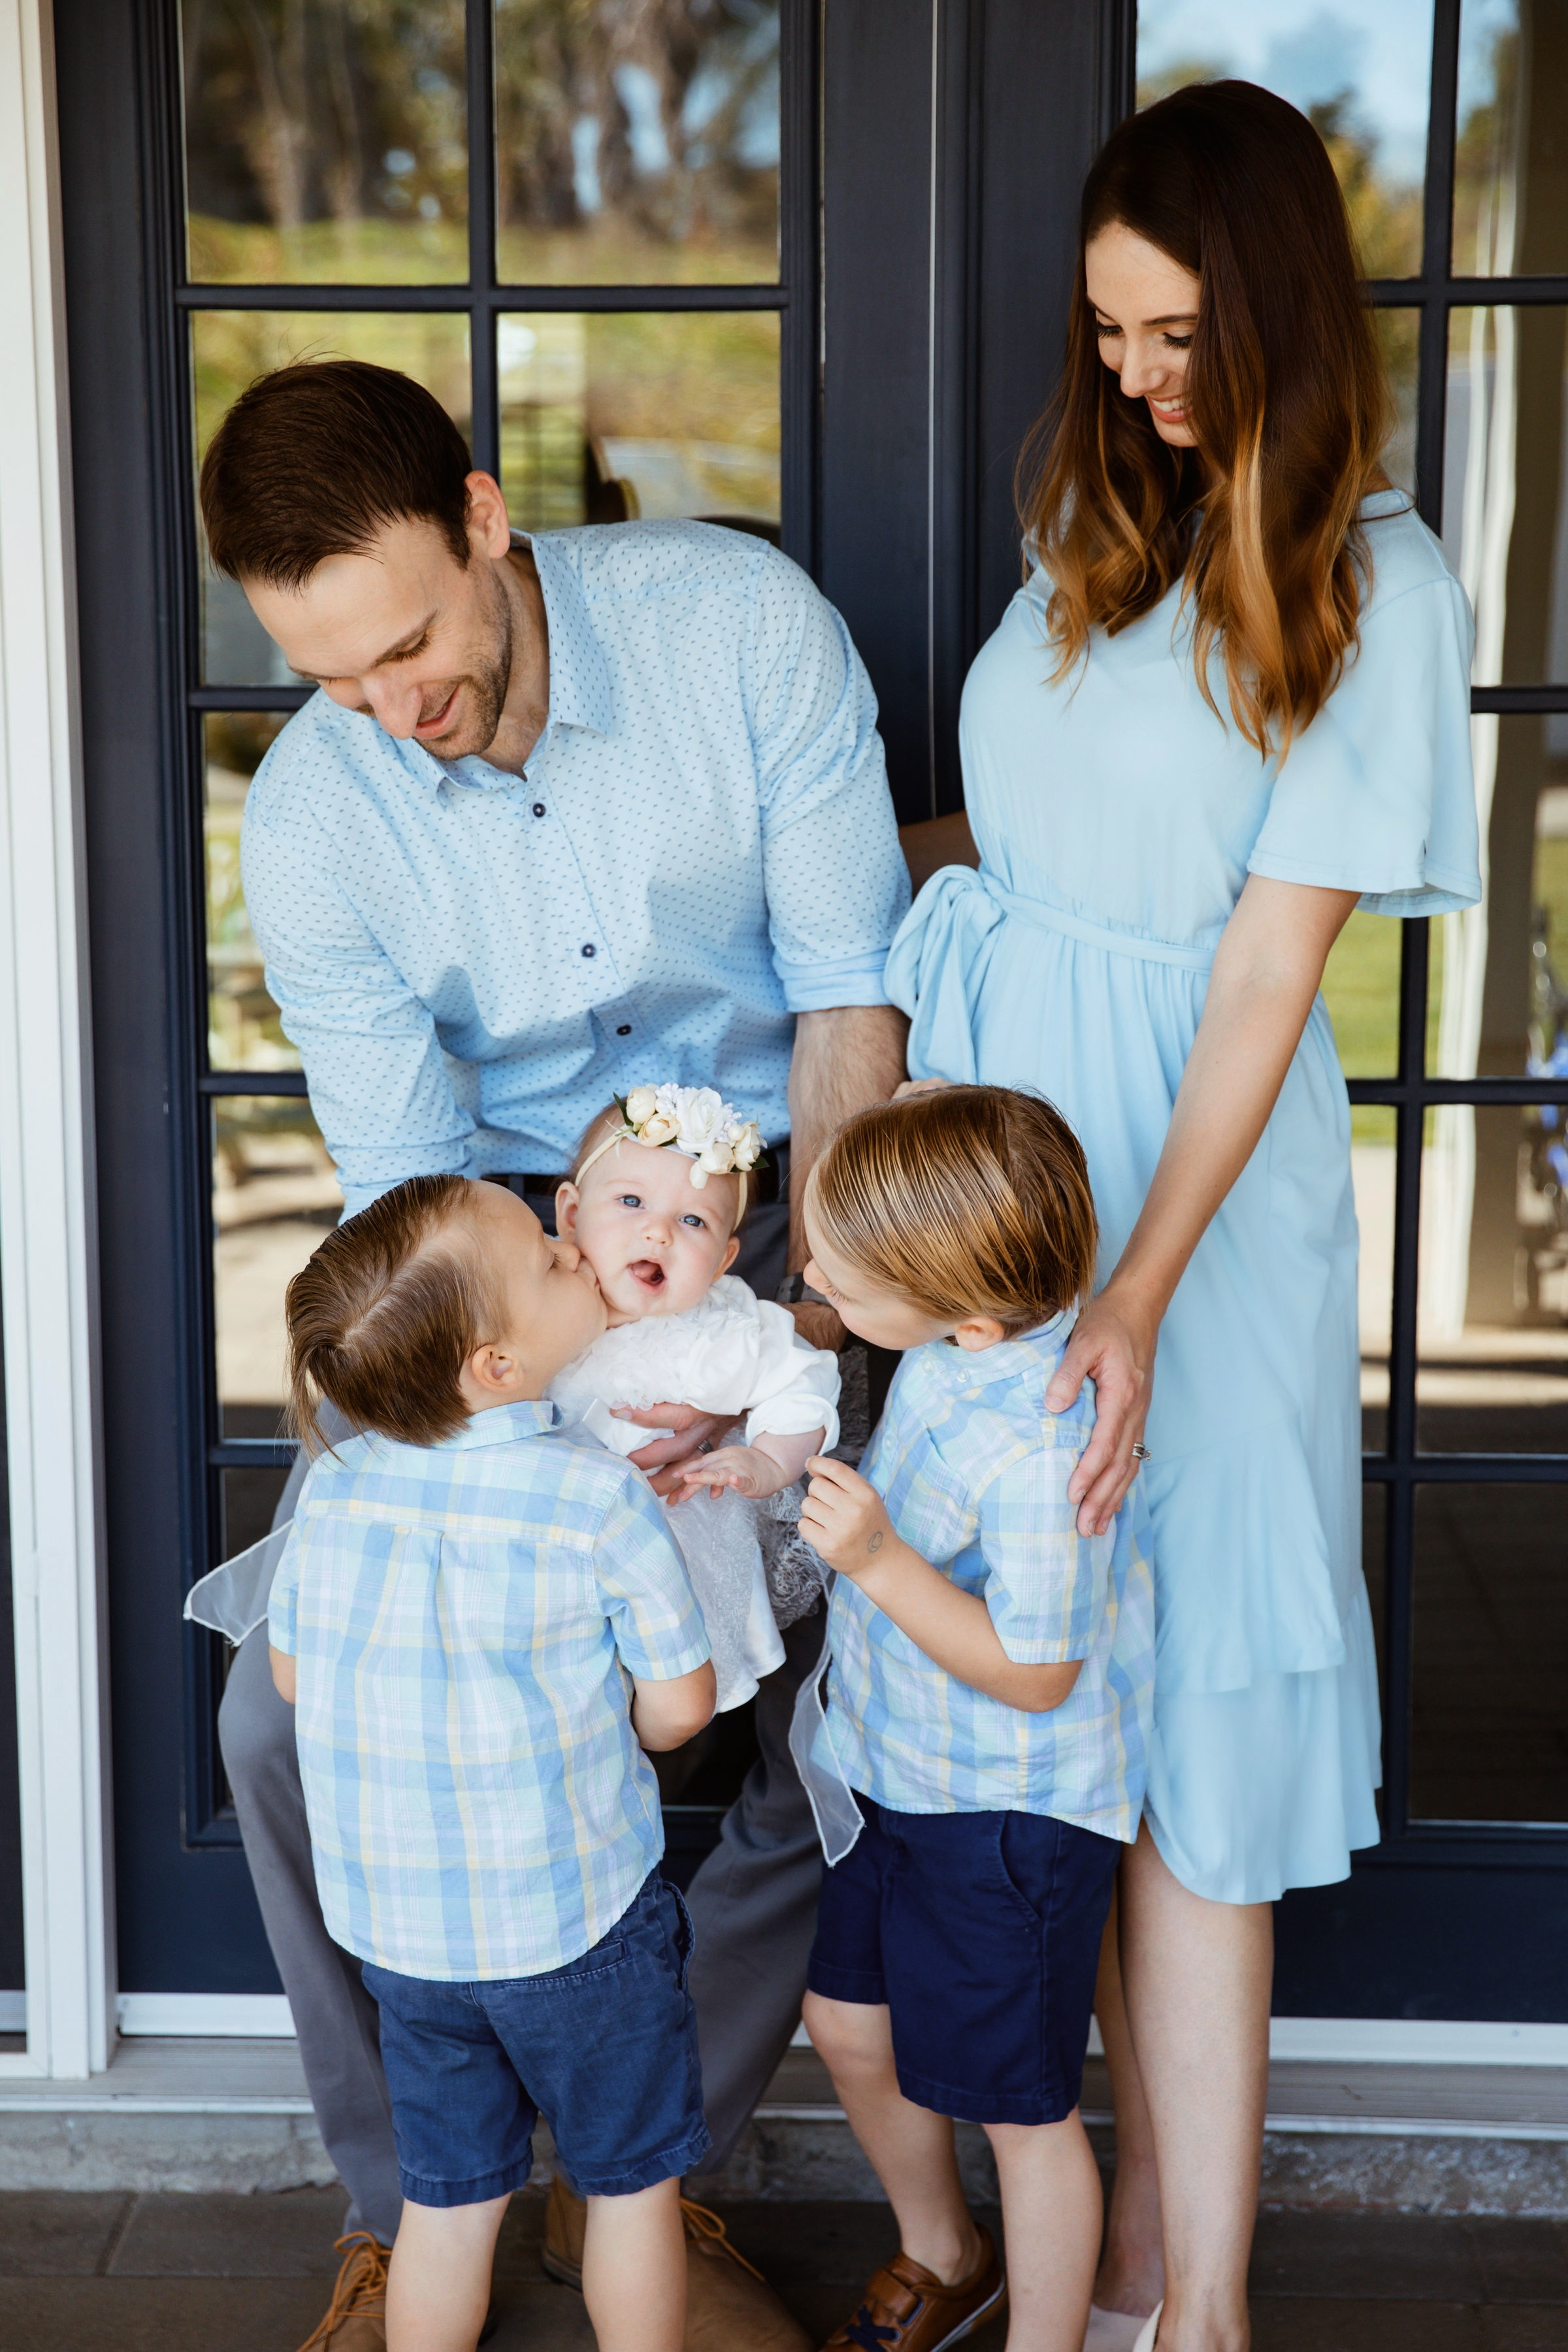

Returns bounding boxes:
[1046,875,1356,1536]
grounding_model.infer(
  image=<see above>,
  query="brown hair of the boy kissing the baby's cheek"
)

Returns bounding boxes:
[284,1176,494,1454]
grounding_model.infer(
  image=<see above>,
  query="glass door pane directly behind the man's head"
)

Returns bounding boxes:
[190,310,470,687]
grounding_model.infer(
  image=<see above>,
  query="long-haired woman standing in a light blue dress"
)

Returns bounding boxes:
[889,82,1478,2352]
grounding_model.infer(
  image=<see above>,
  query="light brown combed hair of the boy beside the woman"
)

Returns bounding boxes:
[806,1086,1100,1338]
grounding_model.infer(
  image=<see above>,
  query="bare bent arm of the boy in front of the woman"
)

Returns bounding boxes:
[799,1454,1084,1714]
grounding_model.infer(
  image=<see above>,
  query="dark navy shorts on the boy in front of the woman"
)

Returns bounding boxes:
[806,1797,1121,2124]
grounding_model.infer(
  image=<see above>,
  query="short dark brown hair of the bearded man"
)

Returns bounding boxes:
[202,360,472,588]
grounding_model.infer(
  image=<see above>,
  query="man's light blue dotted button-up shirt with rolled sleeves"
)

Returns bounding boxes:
[242,522,910,1214]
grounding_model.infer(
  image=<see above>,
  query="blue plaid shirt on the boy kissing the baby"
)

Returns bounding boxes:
[268,1404,708,1980]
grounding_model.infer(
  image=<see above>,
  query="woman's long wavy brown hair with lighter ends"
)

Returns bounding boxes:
[1021,82,1390,755]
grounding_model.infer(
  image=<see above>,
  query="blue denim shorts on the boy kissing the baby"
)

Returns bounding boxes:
[365,1872,712,2206]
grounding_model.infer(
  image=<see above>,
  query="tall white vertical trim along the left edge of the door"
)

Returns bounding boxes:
[0,0,113,2077]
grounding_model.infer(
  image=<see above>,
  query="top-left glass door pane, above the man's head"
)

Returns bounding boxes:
[184,0,468,285]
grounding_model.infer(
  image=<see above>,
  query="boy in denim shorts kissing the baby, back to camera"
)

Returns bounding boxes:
[270,1176,715,2352]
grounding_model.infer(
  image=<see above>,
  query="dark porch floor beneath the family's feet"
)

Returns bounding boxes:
[0,2190,1568,2352]
